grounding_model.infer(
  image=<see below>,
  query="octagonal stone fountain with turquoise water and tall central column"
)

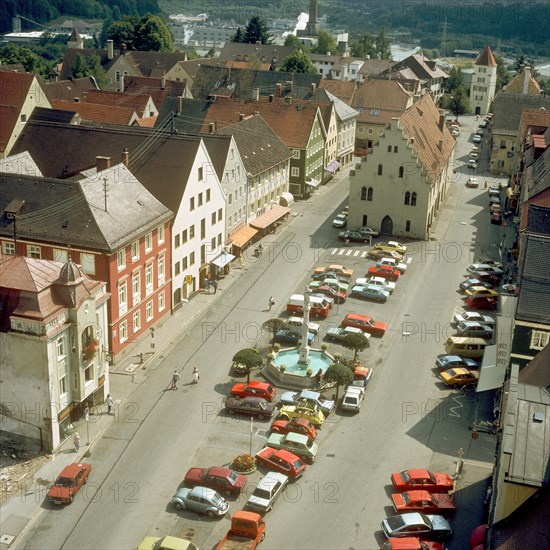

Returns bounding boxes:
[262,288,334,389]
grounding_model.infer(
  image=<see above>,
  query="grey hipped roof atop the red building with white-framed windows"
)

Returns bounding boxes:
[0,163,172,252]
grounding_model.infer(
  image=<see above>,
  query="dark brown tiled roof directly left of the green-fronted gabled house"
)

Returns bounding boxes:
[218,115,292,177]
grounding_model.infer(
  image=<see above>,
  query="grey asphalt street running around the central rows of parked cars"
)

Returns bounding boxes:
[9,117,508,550]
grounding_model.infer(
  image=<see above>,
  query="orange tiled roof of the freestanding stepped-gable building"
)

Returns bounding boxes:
[399,94,456,183]
